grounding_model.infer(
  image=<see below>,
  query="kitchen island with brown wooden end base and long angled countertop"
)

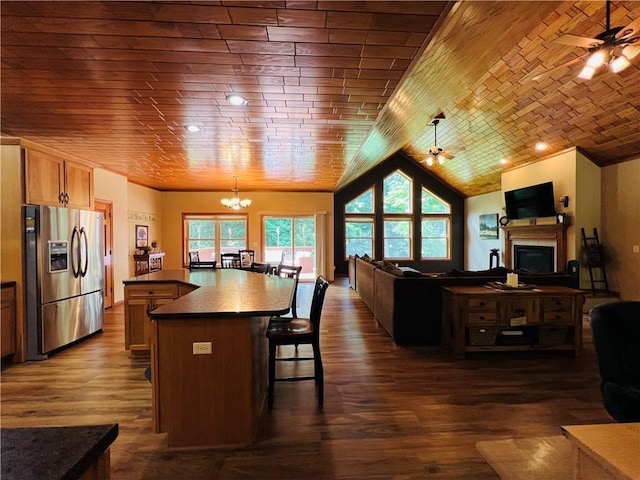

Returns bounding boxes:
[124,269,294,448]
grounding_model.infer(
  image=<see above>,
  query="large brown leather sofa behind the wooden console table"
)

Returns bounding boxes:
[349,256,575,345]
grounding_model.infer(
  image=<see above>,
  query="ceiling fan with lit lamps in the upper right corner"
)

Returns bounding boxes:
[533,0,640,80]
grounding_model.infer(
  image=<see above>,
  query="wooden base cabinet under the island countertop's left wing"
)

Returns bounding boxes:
[124,282,196,353]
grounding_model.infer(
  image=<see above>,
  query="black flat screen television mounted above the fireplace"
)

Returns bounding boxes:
[504,182,556,220]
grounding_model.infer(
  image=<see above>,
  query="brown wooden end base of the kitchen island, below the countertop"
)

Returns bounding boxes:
[151,317,268,448]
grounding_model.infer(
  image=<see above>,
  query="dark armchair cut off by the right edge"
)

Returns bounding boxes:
[589,302,640,422]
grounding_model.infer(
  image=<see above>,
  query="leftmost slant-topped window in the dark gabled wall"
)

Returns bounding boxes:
[344,188,375,258]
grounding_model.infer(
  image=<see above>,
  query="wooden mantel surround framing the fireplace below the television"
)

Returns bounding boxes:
[502,223,567,272]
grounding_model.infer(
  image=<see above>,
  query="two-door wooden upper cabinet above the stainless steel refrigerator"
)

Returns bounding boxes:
[25,149,93,209]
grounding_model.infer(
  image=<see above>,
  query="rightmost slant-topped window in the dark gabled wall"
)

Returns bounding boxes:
[420,188,451,260]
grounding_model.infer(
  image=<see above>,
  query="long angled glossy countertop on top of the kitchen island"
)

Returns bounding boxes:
[124,268,294,320]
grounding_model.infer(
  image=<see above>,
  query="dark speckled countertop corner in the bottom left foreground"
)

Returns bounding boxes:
[0,423,118,480]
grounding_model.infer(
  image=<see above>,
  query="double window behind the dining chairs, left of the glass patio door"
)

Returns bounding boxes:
[183,214,247,265]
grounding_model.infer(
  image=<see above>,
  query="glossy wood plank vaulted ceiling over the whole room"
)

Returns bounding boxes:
[0,1,640,196]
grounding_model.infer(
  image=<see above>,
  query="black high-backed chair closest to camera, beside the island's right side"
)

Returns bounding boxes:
[266,276,329,409]
